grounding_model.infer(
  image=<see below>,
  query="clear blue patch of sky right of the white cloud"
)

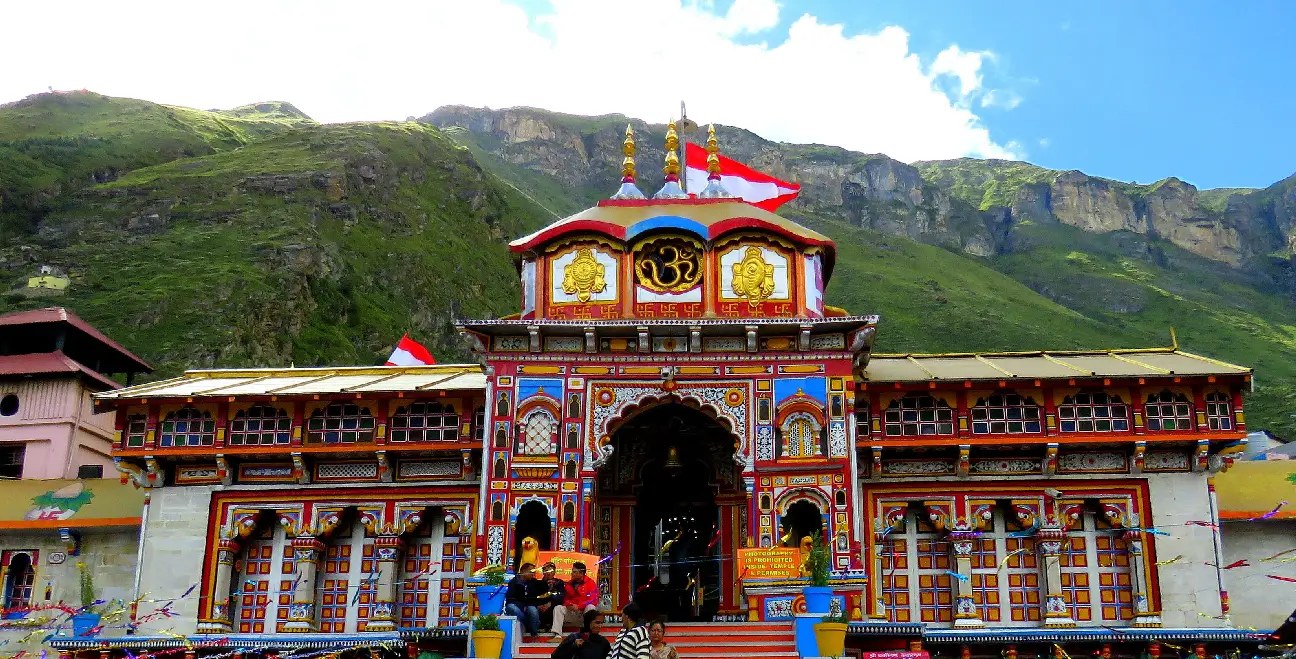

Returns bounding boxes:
[751,0,1296,188]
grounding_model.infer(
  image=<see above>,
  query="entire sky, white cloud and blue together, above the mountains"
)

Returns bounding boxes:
[0,0,1296,188]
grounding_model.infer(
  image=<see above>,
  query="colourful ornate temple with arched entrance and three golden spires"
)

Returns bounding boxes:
[32,126,1275,659]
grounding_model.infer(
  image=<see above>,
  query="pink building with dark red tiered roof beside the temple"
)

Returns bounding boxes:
[0,307,152,479]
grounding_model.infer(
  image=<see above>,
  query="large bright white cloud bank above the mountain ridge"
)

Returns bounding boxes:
[0,0,1016,161]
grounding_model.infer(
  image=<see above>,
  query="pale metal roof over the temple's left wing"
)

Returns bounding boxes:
[96,365,486,402]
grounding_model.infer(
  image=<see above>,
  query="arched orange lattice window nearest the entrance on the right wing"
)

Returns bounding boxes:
[881,509,954,624]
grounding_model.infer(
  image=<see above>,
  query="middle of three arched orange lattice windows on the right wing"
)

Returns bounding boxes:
[971,510,1041,625]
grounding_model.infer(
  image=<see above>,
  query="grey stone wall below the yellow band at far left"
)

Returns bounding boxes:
[0,527,144,656]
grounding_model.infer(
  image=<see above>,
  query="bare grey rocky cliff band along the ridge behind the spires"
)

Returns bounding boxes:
[422,106,1296,269]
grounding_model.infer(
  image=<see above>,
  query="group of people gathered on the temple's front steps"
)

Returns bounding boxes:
[504,562,679,659]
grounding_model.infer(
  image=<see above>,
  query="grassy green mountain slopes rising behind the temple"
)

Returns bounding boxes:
[0,93,1296,433]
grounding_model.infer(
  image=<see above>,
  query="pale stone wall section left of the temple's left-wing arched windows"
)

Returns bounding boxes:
[139,485,216,636]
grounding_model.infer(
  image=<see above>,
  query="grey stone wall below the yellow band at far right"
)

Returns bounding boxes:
[1220,520,1296,632]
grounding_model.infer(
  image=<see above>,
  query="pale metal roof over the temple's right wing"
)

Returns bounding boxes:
[864,348,1251,383]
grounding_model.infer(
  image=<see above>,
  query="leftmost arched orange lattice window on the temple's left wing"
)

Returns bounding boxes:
[233,524,294,634]
